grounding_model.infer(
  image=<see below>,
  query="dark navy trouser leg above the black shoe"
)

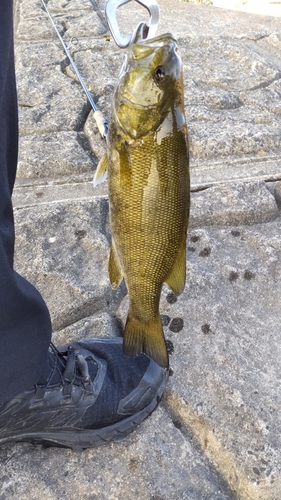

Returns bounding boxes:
[0,0,51,403]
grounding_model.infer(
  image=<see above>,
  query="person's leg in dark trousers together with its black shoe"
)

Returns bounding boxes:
[0,0,168,448]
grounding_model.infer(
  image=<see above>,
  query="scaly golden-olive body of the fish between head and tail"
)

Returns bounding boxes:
[110,132,189,319]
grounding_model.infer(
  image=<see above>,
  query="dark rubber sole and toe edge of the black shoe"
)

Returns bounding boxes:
[0,356,168,450]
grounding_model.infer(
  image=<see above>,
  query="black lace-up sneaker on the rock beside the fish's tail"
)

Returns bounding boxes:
[0,338,168,449]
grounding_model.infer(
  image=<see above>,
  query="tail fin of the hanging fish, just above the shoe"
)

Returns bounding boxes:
[123,312,169,368]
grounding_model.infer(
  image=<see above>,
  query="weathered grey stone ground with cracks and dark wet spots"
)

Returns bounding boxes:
[0,0,281,500]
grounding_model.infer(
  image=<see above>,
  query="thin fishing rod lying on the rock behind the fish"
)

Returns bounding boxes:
[41,0,108,140]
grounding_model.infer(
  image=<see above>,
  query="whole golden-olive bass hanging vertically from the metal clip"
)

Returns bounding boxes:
[94,33,190,369]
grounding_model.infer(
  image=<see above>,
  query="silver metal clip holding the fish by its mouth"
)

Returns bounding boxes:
[105,0,159,49]
